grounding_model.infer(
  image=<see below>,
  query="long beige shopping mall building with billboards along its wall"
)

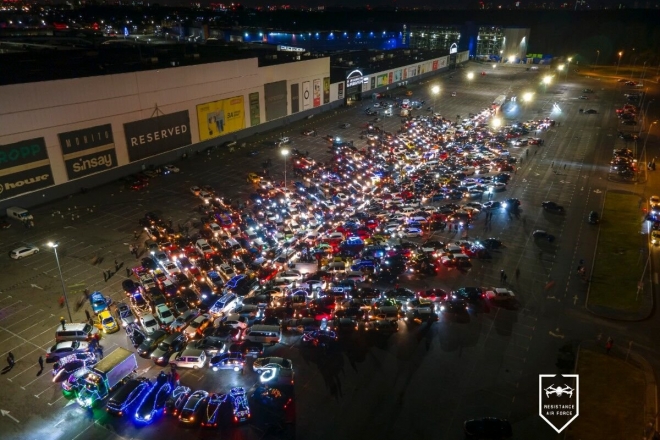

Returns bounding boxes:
[0,43,468,212]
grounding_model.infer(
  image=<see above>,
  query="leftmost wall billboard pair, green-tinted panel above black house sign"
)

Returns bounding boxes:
[0,138,55,200]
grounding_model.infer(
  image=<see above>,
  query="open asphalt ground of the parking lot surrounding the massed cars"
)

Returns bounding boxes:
[0,65,660,440]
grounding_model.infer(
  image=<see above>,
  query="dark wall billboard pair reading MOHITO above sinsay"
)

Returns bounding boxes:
[57,124,117,180]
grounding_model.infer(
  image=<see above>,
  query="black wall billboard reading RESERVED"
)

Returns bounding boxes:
[124,110,191,162]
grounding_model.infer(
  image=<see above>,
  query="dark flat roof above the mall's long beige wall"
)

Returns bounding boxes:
[0,37,327,85]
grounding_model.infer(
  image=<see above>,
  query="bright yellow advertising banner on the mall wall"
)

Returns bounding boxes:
[197,96,245,141]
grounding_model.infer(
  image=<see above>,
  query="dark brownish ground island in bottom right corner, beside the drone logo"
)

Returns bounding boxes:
[565,343,657,440]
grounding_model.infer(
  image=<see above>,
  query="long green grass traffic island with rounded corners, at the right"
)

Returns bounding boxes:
[586,191,653,321]
